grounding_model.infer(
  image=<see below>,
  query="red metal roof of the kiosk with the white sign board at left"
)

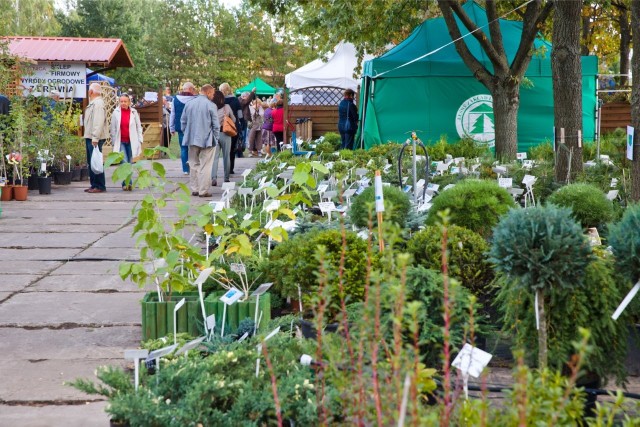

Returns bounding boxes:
[7,37,133,68]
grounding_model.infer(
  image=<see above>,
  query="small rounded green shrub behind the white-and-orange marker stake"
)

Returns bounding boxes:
[349,186,411,227]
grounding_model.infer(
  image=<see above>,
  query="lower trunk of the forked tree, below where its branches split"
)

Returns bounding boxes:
[490,75,520,161]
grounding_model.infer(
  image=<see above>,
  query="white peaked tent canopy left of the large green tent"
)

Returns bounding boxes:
[284,42,373,91]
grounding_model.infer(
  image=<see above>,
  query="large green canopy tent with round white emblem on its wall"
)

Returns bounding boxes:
[359,1,598,151]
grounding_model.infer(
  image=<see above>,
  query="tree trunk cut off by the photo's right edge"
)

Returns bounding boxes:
[631,0,640,202]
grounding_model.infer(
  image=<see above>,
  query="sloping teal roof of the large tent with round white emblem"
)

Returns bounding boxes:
[364,1,551,78]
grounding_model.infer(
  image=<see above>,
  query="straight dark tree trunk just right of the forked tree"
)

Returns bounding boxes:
[551,0,582,183]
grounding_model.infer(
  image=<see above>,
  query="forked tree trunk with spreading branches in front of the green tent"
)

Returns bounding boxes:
[438,0,553,159]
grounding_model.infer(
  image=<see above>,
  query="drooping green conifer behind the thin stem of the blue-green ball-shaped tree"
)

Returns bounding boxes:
[497,251,628,385]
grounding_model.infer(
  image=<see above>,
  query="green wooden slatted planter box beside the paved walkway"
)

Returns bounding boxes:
[141,292,271,341]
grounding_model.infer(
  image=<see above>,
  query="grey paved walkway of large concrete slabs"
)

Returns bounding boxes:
[0,158,257,427]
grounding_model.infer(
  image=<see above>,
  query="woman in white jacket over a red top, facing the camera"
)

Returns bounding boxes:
[111,94,142,191]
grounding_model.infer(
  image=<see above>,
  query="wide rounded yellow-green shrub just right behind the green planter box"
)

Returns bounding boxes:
[265,230,367,313]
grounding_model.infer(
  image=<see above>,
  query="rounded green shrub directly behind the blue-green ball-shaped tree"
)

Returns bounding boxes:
[547,183,613,228]
